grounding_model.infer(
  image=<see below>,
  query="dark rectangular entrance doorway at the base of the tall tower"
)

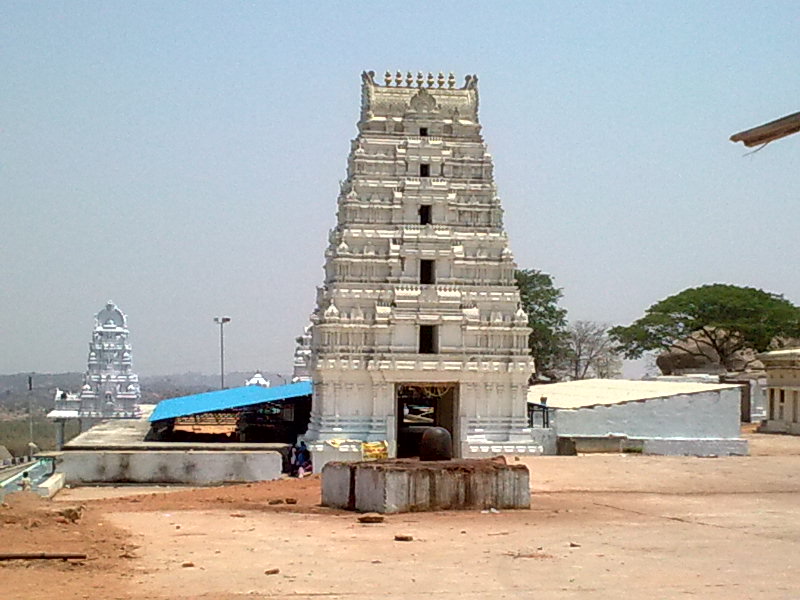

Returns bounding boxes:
[395,383,460,458]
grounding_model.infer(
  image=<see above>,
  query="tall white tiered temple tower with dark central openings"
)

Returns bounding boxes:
[306,72,541,458]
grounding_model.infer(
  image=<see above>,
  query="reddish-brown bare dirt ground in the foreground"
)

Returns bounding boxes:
[0,434,800,600]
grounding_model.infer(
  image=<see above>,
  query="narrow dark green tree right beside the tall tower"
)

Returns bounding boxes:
[514,269,567,379]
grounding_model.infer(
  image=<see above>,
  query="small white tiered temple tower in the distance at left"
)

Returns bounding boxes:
[47,300,142,446]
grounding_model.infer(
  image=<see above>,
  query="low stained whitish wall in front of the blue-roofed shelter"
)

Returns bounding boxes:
[57,450,281,485]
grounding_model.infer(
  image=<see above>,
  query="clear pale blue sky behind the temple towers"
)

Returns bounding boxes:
[0,0,800,374]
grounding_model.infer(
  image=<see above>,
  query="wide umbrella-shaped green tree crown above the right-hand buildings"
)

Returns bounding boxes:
[609,283,800,368]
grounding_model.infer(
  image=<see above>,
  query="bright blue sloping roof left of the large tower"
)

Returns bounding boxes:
[150,381,311,423]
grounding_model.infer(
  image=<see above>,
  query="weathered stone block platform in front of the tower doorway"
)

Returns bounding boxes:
[322,459,531,513]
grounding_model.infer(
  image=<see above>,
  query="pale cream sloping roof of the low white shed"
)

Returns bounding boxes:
[528,379,737,409]
